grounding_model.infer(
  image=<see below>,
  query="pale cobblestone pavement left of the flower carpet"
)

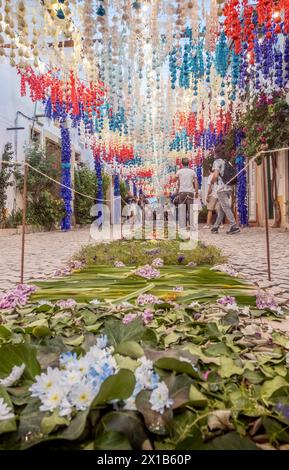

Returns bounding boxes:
[0,229,90,292]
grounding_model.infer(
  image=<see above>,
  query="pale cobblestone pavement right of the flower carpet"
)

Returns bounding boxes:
[199,227,289,306]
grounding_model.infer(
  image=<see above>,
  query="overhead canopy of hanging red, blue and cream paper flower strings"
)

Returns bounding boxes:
[0,0,289,195]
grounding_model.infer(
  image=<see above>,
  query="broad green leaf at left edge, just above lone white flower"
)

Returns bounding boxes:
[0,343,41,380]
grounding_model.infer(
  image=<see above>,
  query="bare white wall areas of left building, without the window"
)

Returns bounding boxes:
[0,59,92,210]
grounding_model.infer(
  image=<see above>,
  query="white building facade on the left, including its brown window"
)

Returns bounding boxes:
[0,59,92,212]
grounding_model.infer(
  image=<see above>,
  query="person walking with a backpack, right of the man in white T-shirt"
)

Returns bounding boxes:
[211,144,240,235]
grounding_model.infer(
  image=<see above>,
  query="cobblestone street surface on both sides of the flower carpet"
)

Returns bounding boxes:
[0,228,289,303]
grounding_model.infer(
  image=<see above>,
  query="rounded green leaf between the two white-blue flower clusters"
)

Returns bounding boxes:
[92,369,135,408]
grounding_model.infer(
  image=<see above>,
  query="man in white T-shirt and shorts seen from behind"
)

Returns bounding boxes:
[176,158,199,228]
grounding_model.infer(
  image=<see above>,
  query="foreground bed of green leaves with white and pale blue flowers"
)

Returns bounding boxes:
[0,274,289,450]
